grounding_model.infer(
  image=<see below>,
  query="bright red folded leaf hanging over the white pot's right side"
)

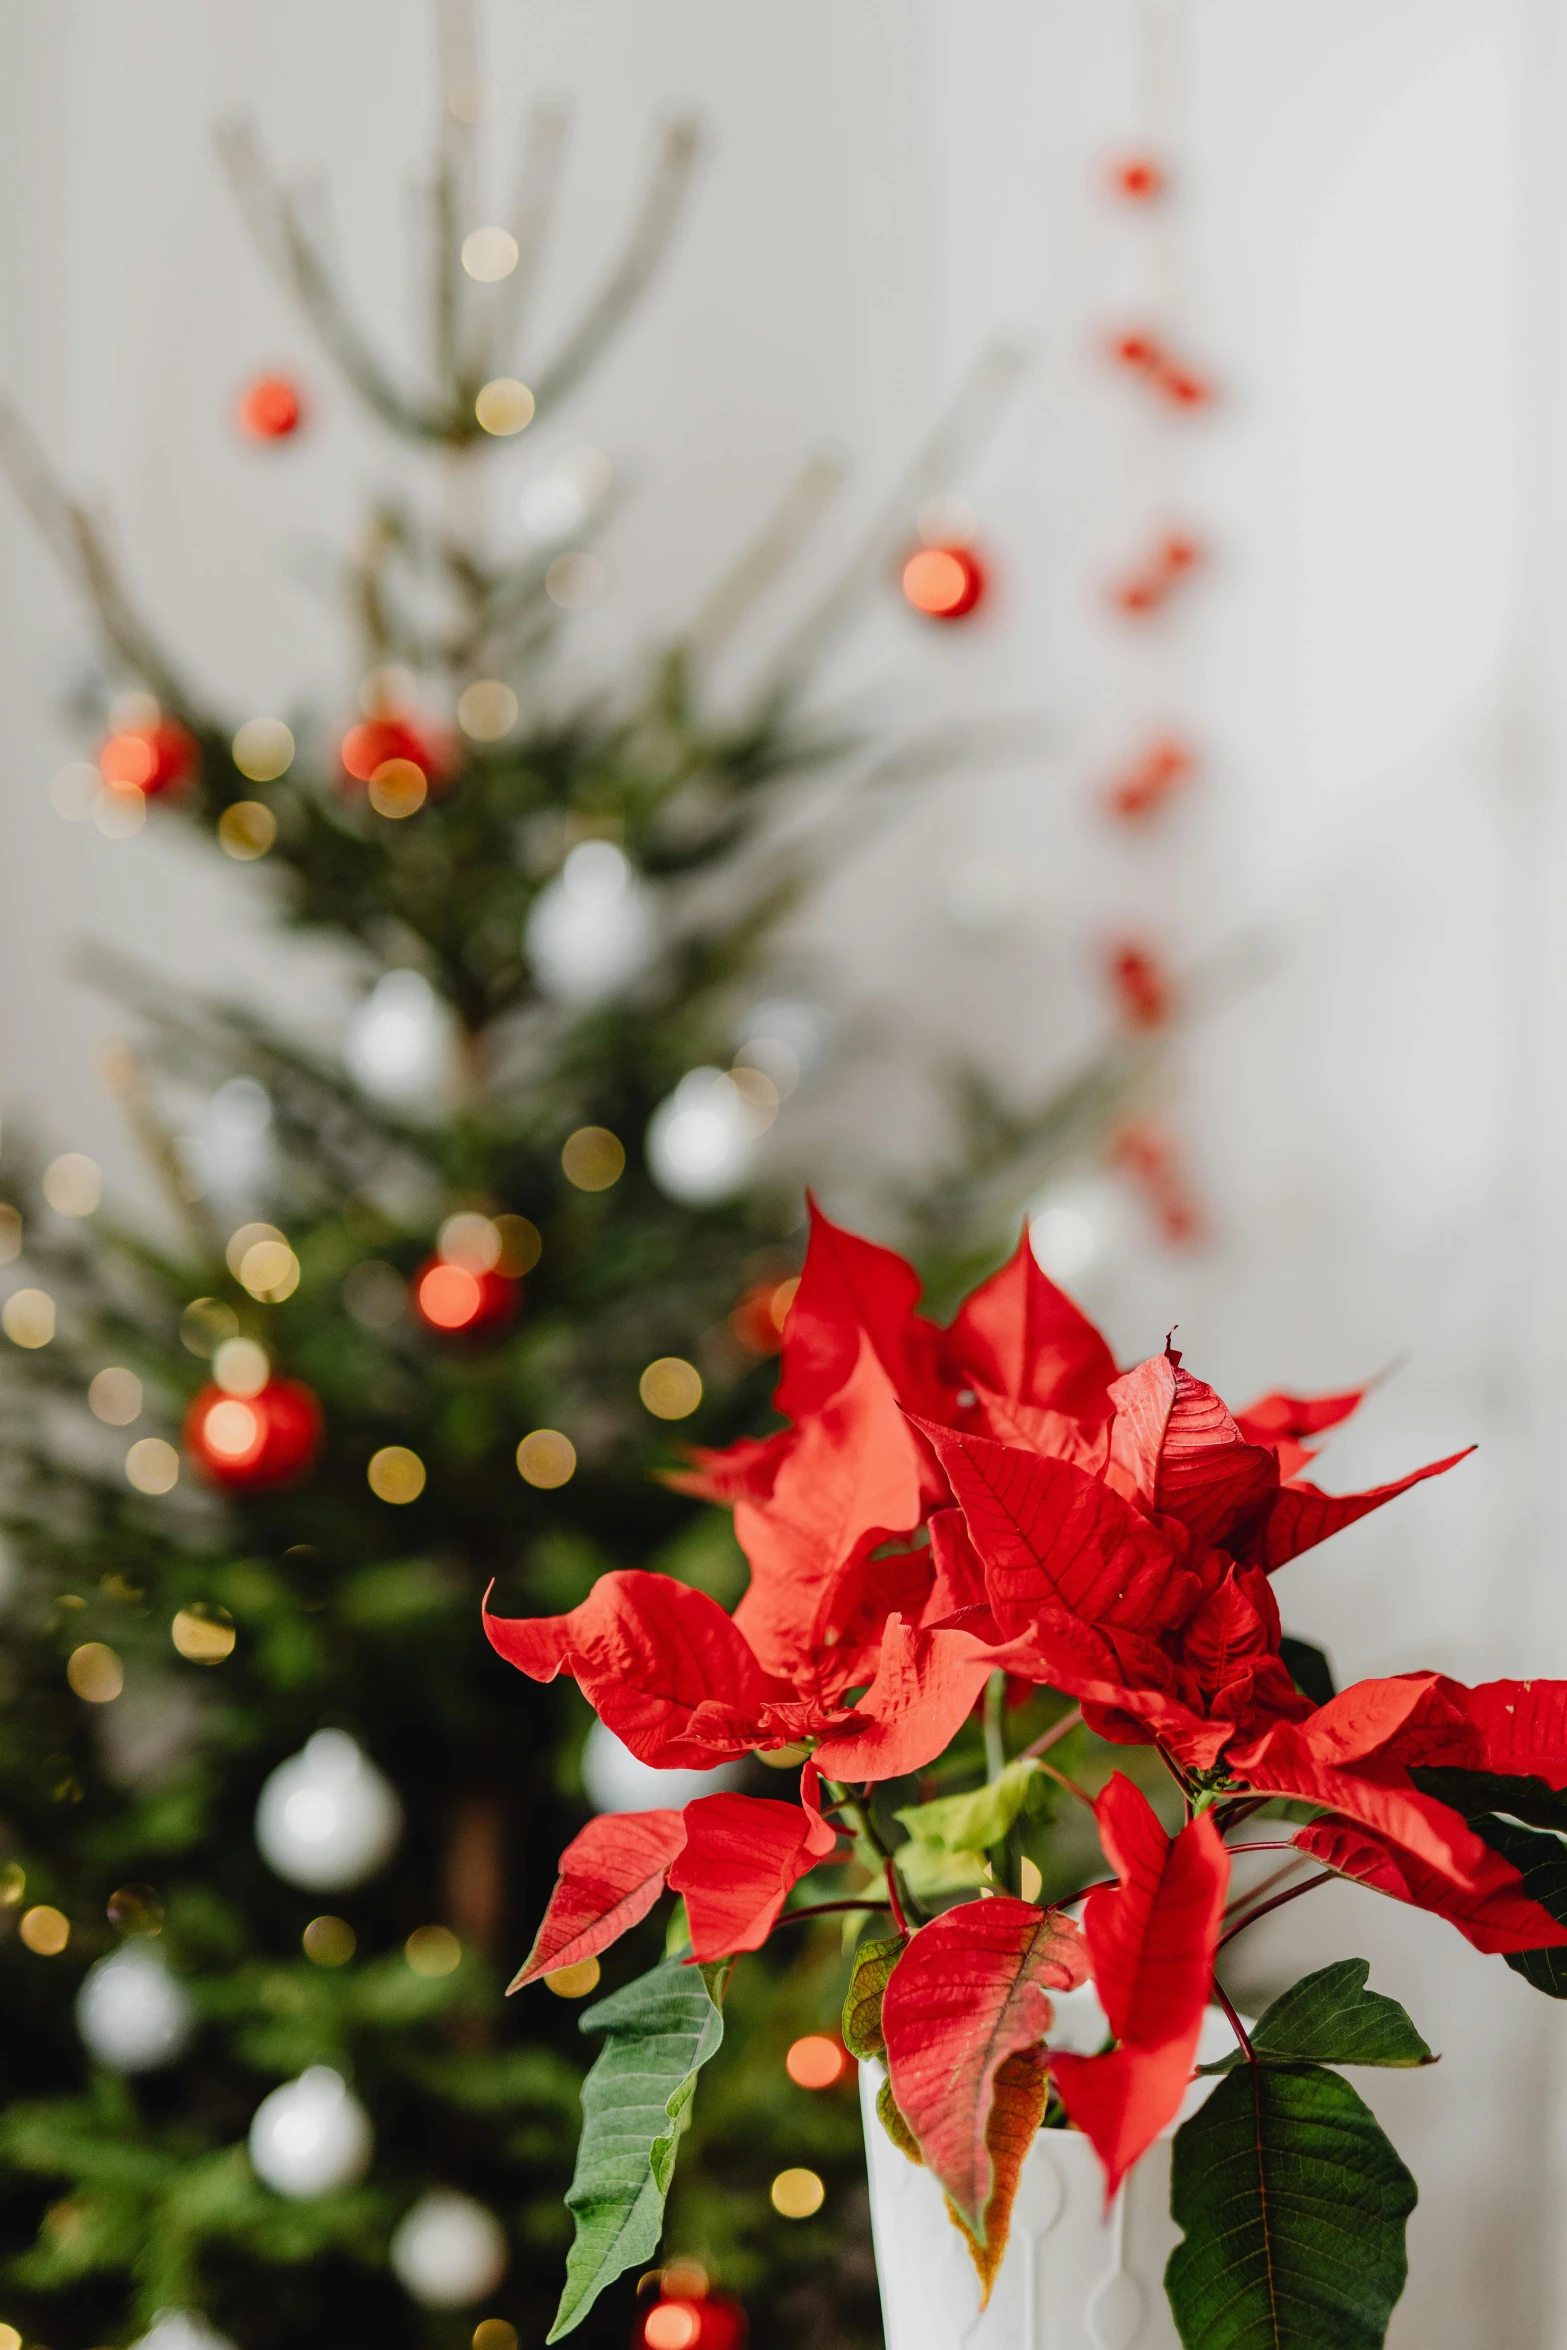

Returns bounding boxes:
[1050,1772,1229,2197]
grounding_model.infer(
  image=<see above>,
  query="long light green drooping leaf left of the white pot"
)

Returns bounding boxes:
[547,1960,724,2341]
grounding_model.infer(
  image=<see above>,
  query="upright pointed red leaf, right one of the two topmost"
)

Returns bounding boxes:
[942,1231,1116,1422]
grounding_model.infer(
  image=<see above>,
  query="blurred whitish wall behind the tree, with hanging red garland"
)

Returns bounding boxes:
[0,0,1567,2350]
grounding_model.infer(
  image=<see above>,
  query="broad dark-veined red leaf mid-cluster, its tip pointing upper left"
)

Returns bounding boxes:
[916,1419,1201,1636]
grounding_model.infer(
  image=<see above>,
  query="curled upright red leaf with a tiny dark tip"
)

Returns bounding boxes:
[1111,1347,1278,1546]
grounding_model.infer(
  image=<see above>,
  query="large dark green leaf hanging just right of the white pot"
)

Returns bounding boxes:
[1165,2063,1414,2350]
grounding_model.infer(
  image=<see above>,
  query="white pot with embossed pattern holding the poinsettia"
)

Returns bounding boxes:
[860,1993,1236,2350]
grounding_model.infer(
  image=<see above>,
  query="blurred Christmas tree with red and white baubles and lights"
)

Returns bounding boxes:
[0,27,1137,2350]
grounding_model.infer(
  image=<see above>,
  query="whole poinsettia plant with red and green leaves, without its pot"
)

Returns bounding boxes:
[486,1215,1567,2350]
